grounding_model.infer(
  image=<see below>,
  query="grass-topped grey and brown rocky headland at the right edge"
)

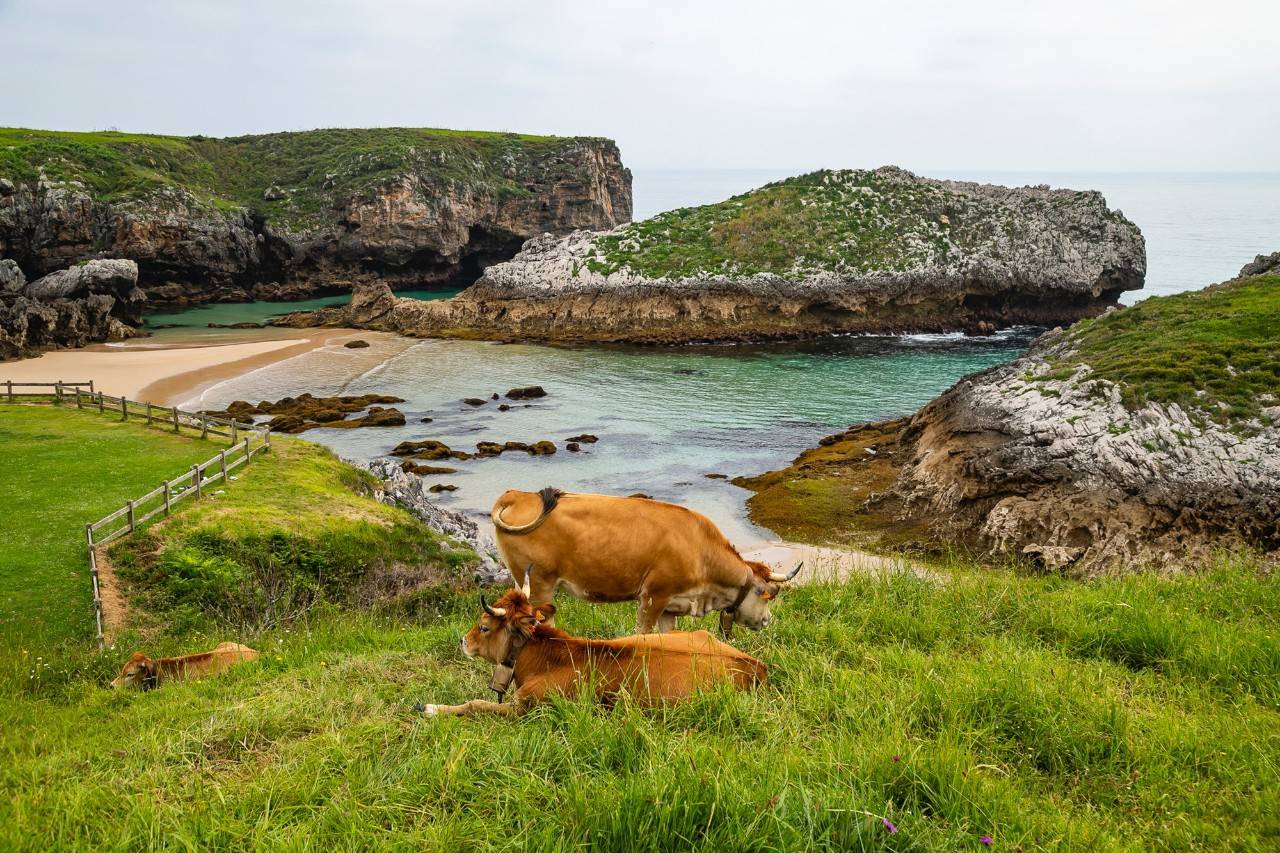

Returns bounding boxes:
[742,255,1280,574]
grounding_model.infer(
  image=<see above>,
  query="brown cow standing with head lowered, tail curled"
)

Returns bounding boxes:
[490,489,800,635]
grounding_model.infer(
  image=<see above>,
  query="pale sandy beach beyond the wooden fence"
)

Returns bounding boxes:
[0,329,367,405]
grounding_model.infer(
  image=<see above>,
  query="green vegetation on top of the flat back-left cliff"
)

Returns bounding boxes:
[0,128,614,227]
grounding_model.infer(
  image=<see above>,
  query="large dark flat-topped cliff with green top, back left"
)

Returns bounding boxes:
[0,122,631,304]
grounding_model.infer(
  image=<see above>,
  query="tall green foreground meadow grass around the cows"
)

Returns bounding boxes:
[0,562,1280,850]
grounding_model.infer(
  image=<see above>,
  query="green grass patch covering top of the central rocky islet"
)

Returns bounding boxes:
[585,169,1119,278]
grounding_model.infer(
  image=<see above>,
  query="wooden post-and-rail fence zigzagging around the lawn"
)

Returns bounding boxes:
[4,380,271,648]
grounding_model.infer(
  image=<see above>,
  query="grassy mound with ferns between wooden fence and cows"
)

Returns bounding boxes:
[109,438,475,642]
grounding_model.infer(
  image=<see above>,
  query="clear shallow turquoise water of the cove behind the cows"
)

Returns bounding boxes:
[184,329,1032,544]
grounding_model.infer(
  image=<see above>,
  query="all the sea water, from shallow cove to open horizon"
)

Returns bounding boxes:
[141,169,1280,547]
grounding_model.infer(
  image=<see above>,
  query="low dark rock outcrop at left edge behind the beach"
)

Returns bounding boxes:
[0,259,146,360]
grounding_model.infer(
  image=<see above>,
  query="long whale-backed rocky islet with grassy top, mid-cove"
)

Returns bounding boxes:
[289,167,1146,343]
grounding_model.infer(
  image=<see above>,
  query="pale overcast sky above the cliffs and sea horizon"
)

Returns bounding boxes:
[0,0,1280,170]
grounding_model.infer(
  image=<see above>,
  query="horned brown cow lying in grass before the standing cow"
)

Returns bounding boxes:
[417,581,767,716]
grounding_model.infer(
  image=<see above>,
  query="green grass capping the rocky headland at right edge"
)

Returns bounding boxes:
[1056,275,1280,421]
